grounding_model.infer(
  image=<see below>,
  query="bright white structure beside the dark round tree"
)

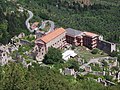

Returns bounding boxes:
[62,50,77,61]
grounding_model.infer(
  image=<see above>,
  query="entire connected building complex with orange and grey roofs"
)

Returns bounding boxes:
[33,28,116,61]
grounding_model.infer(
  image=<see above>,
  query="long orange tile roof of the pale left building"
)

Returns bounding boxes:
[37,28,66,43]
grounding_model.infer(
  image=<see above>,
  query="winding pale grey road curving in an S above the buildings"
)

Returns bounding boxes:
[25,10,55,33]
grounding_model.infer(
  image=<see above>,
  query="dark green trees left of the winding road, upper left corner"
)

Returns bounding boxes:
[0,0,29,44]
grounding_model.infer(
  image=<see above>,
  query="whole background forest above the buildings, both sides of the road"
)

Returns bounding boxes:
[0,0,120,44]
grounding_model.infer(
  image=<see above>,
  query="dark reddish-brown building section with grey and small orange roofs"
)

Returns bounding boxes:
[66,28,99,49]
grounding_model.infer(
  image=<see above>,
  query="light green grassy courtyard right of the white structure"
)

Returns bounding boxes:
[75,46,107,61]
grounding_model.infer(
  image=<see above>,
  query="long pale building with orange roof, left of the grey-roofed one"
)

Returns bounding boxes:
[34,28,66,61]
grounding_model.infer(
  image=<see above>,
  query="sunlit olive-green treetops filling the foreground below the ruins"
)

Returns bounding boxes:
[0,63,119,90]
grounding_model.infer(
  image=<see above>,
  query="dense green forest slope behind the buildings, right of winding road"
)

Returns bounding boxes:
[19,0,120,43]
